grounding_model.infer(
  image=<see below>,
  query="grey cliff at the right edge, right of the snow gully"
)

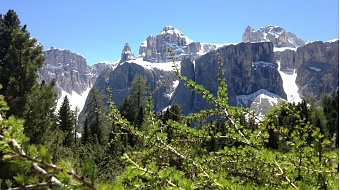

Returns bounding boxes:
[295,40,339,99]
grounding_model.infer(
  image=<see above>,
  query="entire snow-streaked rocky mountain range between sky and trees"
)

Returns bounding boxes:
[39,26,339,118]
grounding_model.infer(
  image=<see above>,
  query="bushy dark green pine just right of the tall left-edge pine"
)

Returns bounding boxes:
[23,80,57,144]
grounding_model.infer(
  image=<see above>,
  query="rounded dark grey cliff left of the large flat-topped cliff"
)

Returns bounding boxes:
[85,62,176,111]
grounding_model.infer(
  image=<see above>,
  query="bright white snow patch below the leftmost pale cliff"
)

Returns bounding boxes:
[57,87,91,114]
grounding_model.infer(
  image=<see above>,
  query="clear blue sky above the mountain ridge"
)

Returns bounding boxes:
[0,0,339,65]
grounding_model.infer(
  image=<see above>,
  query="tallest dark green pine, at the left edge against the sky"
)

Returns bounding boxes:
[0,10,44,117]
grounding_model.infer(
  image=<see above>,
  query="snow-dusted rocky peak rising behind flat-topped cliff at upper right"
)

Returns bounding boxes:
[242,26,305,48]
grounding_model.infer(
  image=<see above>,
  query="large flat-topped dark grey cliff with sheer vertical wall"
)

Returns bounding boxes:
[173,43,286,113]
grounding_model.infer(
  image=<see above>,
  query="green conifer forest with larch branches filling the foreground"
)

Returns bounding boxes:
[0,10,339,190]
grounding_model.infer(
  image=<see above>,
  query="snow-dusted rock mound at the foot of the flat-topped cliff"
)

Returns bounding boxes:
[236,89,282,107]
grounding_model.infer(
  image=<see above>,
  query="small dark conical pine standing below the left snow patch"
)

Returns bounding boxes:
[58,96,74,146]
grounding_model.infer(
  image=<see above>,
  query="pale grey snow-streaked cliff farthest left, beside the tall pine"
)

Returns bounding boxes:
[38,47,109,97]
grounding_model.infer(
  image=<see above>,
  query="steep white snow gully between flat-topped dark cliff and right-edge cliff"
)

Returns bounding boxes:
[277,61,302,104]
